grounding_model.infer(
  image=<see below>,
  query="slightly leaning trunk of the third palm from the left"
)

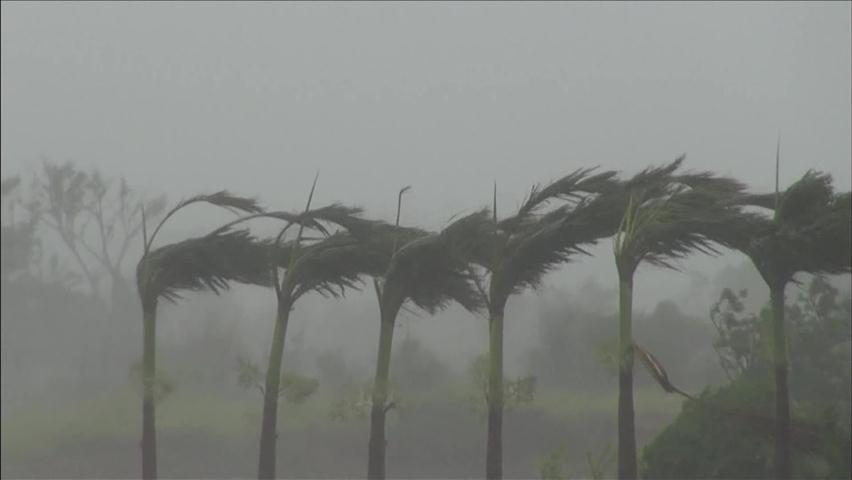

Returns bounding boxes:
[367,295,401,480]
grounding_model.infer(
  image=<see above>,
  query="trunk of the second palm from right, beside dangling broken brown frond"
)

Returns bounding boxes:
[618,278,637,480]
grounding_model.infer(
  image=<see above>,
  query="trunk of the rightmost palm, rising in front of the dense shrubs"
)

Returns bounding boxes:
[769,284,793,480]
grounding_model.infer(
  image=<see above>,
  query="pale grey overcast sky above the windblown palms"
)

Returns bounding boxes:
[1,2,852,308]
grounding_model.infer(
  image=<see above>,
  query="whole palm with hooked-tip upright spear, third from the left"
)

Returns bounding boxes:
[362,204,488,479]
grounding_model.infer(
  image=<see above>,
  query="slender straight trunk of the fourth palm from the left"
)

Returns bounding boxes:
[485,309,503,480]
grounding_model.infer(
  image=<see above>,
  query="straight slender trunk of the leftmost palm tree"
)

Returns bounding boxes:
[142,298,157,480]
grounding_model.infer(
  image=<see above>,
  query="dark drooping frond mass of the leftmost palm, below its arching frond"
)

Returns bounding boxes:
[136,230,270,302]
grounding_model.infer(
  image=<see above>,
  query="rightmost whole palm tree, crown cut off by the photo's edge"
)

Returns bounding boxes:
[734,162,852,479]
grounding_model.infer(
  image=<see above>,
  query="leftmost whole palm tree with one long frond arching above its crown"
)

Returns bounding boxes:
[136,191,269,479]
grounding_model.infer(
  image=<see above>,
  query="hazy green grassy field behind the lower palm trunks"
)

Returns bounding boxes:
[2,388,680,478]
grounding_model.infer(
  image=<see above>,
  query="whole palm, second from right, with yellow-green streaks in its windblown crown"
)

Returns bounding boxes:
[611,157,744,479]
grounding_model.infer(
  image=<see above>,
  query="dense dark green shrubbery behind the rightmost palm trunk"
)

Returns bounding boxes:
[643,277,852,478]
